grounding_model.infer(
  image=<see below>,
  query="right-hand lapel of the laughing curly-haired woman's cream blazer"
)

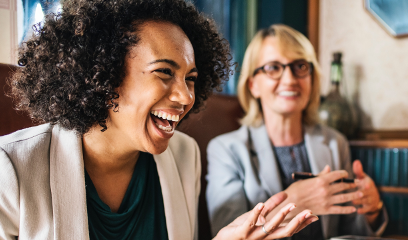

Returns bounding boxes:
[154,148,194,240]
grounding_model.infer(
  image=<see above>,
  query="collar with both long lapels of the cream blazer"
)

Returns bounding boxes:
[50,125,193,240]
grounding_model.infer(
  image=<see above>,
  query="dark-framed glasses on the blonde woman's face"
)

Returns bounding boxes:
[252,59,313,80]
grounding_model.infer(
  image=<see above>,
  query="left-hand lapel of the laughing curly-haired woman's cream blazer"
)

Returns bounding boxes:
[50,125,89,239]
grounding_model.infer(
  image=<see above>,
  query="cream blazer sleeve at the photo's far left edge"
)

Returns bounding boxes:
[0,148,20,240]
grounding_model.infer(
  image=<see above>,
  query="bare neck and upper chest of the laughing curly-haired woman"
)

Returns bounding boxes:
[82,125,140,176]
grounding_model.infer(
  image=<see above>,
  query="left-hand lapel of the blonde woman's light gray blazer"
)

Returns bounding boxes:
[248,125,283,196]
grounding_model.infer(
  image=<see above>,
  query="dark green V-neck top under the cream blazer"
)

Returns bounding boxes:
[85,152,168,240]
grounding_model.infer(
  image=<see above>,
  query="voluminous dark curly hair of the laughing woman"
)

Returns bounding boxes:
[10,0,233,134]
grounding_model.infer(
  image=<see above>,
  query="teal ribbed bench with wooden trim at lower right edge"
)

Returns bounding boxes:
[350,140,408,239]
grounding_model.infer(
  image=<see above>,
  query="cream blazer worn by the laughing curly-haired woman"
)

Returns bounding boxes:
[0,124,201,240]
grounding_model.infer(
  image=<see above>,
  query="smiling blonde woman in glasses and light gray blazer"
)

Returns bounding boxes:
[207,25,387,240]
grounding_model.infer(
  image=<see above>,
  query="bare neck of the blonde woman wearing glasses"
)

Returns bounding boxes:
[264,111,303,147]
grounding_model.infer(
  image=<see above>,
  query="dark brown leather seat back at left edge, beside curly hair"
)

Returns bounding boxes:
[0,63,33,136]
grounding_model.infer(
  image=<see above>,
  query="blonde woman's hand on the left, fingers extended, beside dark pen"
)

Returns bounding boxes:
[285,166,364,219]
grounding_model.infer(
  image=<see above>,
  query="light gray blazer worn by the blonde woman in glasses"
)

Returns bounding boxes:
[206,125,388,238]
